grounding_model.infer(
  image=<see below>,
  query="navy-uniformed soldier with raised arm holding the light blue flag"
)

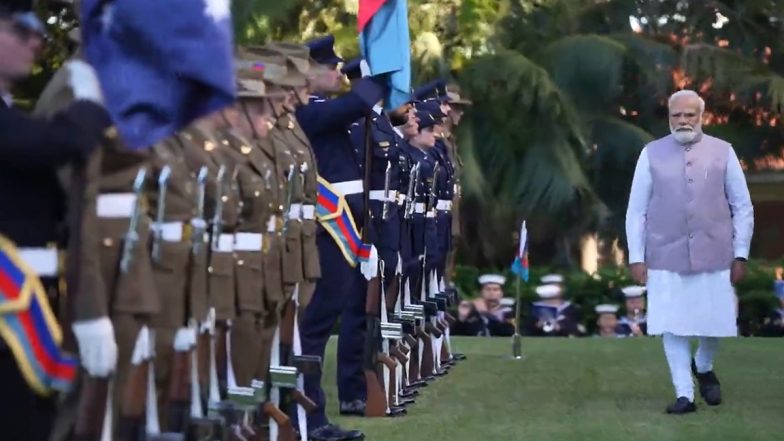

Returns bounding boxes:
[296,36,386,440]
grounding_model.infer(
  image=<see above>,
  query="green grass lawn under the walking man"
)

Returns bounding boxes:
[318,338,784,441]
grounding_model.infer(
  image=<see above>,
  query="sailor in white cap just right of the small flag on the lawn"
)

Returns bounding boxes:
[524,284,585,337]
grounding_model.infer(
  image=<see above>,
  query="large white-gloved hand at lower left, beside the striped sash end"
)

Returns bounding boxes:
[71,317,117,377]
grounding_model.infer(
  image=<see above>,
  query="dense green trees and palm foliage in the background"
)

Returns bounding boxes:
[17,0,784,268]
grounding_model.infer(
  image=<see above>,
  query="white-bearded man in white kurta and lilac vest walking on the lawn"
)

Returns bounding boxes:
[626,90,754,414]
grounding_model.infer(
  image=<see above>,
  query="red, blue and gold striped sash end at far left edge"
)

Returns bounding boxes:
[0,236,79,396]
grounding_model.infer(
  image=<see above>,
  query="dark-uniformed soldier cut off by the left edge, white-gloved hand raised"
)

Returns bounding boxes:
[0,0,116,441]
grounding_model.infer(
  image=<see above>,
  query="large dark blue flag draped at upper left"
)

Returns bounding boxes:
[80,0,235,149]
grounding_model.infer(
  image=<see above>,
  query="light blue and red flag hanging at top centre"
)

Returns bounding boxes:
[359,0,411,110]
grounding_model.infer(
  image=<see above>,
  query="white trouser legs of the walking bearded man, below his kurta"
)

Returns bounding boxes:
[663,332,719,401]
